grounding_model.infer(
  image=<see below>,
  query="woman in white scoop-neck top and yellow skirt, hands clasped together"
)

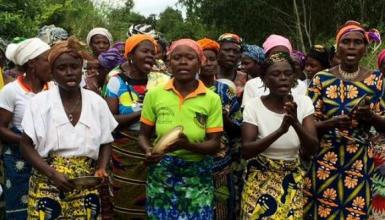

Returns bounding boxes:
[241,53,318,219]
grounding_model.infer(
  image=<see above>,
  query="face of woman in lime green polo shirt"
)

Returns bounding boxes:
[170,45,201,82]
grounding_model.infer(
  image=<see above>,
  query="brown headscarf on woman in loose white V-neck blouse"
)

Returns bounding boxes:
[48,36,87,67]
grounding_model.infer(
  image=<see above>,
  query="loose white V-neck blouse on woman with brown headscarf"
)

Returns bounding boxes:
[21,86,118,160]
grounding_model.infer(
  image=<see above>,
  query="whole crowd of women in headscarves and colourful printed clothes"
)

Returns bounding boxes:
[0,21,385,220]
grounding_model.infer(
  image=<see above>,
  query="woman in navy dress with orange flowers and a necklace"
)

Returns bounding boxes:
[305,21,385,219]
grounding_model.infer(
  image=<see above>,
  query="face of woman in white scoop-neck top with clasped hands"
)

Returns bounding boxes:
[263,61,295,96]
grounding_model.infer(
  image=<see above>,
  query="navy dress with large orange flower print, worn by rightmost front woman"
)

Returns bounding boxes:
[304,70,384,220]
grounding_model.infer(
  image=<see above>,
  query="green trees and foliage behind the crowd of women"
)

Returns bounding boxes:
[0,0,385,67]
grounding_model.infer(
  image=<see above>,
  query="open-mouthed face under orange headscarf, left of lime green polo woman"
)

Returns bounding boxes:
[130,41,156,74]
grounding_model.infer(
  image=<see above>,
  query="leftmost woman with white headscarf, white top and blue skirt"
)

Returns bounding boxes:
[0,38,51,219]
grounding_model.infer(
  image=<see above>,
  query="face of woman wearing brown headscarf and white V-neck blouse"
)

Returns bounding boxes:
[53,53,83,91]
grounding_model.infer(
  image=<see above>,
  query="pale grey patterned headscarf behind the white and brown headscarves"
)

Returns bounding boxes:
[37,24,68,46]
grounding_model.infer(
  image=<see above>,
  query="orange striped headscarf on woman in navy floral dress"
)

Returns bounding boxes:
[336,20,381,45]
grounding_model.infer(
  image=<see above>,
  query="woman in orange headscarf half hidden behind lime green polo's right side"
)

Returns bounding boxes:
[197,38,242,219]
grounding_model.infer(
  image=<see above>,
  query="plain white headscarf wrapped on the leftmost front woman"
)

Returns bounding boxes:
[5,38,51,66]
